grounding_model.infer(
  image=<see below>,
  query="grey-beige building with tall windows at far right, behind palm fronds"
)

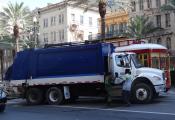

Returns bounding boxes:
[129,0,175,55]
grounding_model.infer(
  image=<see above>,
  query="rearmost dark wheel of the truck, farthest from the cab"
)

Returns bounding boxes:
[26,88,44,105]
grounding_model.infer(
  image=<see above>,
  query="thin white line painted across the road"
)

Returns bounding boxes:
[54,105,175,116]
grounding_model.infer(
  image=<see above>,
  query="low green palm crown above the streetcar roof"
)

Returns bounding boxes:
[126,16,160,40]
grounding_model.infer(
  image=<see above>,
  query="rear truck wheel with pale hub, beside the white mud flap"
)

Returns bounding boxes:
[46,87,64,105]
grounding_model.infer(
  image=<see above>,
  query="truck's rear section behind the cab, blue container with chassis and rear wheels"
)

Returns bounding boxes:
[5,43,113,104]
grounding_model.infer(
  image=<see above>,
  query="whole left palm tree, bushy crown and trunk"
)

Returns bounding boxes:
[0,2,32,52]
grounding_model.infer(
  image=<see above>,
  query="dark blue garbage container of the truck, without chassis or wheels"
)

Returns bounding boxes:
[5,43,112,80]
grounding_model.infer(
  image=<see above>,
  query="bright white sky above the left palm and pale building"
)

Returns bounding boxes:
[0,0,62,10]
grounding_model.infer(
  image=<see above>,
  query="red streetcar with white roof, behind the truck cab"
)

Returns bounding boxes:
[114,40,171,90]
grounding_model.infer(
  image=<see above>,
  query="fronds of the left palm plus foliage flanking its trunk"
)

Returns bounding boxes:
[0,2,33,48]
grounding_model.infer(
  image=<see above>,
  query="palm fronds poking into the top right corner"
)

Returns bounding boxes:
[161,0,175,11]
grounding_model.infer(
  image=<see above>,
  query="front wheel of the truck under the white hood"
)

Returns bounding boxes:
[132,83,153,103]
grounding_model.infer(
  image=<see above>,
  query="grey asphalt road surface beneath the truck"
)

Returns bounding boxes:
[0,92,175,120]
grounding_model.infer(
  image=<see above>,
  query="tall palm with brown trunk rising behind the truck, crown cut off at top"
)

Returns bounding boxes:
[67,0,131,41]
